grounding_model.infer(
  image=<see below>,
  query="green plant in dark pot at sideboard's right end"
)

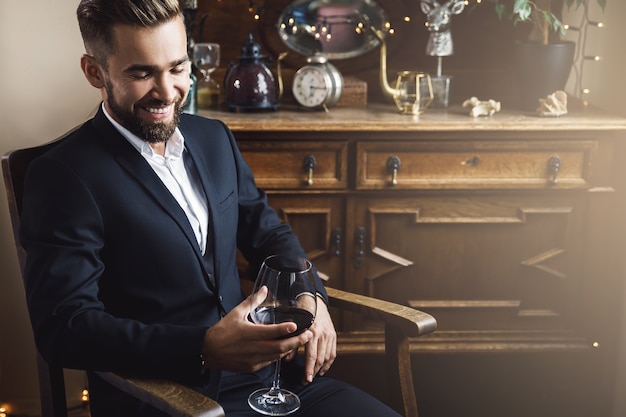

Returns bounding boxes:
[492,0,607,110]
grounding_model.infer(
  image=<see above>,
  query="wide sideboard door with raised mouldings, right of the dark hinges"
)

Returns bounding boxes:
[347,192,585,342]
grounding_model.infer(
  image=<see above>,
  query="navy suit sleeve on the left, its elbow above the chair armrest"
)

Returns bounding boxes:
[20,157,206,378]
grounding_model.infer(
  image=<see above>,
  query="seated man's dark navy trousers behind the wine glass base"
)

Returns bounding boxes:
[90,361,400,417]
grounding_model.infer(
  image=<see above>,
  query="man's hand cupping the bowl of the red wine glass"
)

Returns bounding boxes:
[202,288,312,372]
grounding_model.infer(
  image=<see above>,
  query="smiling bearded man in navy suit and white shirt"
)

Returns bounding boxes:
[20,0,404,417]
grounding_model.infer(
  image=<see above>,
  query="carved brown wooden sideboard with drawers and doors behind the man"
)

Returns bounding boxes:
[201,104,626,417]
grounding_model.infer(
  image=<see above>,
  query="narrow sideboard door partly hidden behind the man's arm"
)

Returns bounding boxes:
[269,194,345,288]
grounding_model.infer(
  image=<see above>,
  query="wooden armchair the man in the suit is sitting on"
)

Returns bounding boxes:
[2,131,437,417]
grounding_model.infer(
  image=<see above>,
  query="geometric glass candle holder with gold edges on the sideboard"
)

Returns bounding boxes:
[393,71,434,115]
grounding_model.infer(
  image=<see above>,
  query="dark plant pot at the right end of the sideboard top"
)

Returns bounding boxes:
[515,41,576,111]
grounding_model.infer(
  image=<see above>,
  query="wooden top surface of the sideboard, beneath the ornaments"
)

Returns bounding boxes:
[198,104,626,132]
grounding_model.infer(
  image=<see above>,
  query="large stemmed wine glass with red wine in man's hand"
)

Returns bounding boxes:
[248,255,317,416]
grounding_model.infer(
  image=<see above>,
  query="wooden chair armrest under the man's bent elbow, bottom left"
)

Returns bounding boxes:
[98,372,225,417]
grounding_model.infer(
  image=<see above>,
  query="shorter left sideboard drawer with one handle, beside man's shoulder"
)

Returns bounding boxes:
[238,141,348,190]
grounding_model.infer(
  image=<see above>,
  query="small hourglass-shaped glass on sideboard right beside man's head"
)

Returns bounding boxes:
[193,42,220,108]
